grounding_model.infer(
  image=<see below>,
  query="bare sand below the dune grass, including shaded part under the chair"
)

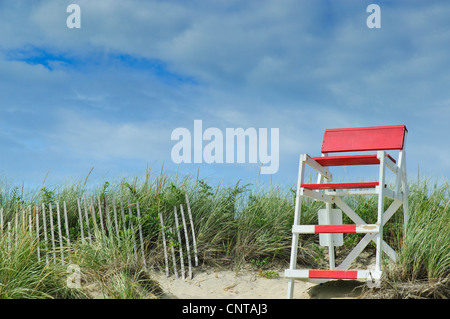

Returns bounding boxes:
[152,269,361,299]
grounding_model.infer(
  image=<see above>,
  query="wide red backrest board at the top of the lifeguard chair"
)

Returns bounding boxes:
[322,125,408,153]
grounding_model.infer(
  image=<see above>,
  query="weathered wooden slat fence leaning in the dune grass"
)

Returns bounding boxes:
[0,194,198,279]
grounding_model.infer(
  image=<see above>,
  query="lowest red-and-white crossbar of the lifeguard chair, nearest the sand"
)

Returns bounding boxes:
[284,269,381,280]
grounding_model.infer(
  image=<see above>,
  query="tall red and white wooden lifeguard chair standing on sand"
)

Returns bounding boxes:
[285,125,408,299]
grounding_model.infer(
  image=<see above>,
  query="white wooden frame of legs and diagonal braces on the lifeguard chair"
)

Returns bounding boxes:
[285,131,408,299]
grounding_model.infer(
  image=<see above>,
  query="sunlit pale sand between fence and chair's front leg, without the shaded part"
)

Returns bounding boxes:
[152,270,315,299]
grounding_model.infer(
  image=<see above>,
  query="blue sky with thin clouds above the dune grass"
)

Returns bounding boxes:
[0,0,450,192]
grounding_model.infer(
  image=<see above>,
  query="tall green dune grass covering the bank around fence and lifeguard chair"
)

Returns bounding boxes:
[0,171,450,298]
